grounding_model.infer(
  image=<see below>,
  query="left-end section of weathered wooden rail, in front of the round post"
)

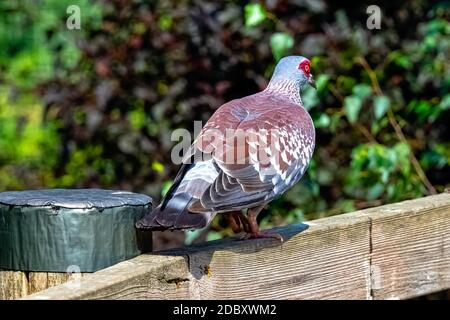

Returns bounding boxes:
[25,255,189,299]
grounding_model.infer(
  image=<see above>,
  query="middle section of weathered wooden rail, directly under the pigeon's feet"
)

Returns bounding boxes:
[181,214,370,299]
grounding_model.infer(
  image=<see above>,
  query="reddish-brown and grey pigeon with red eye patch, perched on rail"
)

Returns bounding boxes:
[136,56,316,241]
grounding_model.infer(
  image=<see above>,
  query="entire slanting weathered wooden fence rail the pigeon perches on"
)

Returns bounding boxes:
[26,194,450,299]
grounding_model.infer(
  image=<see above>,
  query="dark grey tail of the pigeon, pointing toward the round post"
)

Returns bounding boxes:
[136,192,214,231]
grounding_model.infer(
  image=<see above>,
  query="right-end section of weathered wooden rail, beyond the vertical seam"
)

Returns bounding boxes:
[370,195,450,299]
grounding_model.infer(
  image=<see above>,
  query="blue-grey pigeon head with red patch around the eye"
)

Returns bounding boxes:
[273,56,316,89]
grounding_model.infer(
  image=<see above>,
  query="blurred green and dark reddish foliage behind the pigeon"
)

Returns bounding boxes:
[0,0,450,255]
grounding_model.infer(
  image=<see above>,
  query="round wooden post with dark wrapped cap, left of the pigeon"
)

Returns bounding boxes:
[0,189,152,299]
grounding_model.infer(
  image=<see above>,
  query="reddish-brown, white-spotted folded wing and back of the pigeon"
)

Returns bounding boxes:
[189,96,314,212]
